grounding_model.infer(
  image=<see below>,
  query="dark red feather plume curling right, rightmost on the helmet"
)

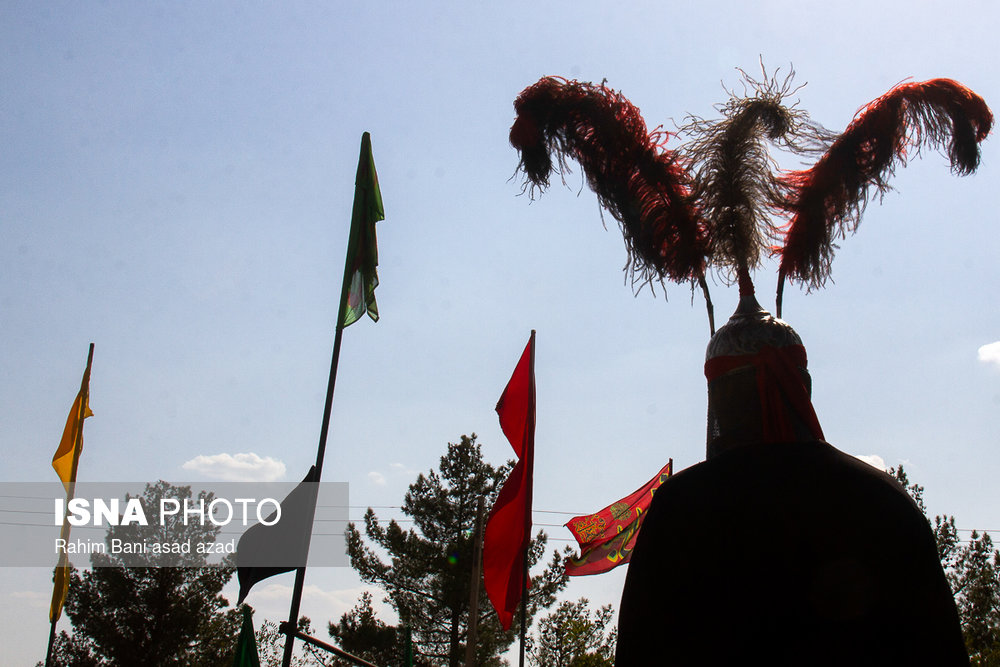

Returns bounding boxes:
[777,79,993,294]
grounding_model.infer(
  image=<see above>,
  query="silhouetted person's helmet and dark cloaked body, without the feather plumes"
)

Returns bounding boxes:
[615,297,969,667]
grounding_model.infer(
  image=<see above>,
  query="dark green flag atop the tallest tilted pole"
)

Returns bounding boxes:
[340,132,385,327]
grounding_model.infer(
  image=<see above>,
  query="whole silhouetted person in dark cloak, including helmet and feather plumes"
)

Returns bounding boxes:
[510,66,993,667]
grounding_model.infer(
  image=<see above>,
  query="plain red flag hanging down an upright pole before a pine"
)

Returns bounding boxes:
[483,331,535,630]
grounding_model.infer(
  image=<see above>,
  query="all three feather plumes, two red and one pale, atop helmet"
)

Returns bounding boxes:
[510,67,993,333]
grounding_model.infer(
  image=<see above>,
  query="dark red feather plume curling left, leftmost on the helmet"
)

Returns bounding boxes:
[510,77,709,282]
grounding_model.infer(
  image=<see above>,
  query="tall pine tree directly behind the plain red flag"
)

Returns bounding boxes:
[341,434,567,667]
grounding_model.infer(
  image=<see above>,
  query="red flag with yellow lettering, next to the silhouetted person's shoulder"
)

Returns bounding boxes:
[566,459,674,577]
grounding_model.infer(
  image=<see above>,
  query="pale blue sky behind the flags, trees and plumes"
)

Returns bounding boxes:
[0,0,1000,667]
